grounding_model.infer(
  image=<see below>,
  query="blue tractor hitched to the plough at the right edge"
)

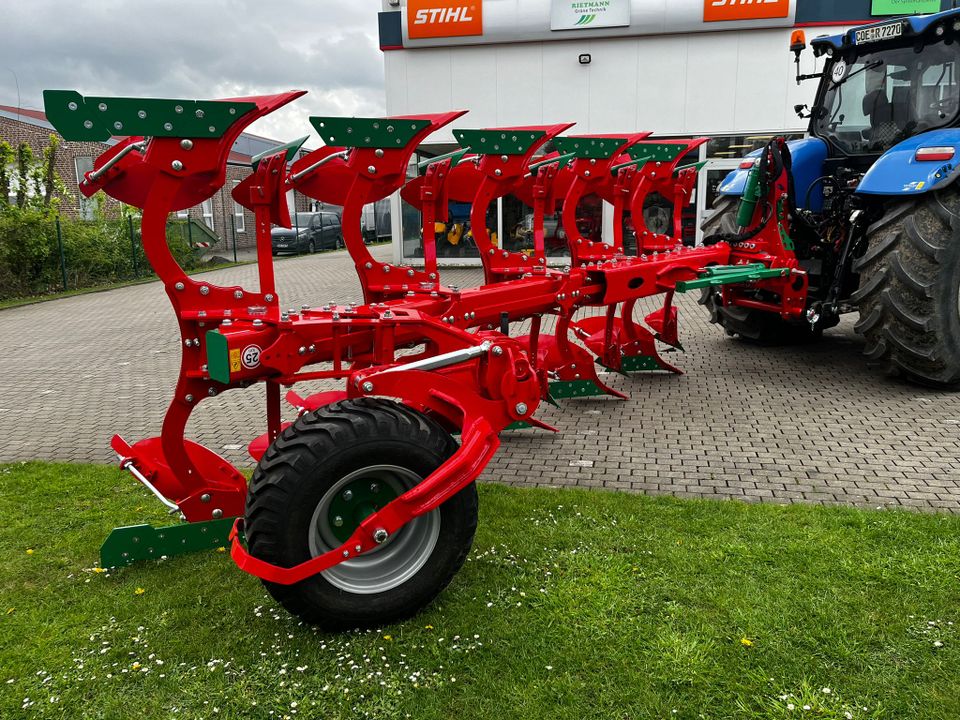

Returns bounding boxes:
[701,10,960,388]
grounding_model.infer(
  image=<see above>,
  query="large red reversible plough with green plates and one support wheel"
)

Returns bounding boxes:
[45,91,804,627]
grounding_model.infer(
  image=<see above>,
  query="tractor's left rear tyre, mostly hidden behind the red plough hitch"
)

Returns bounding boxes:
[699,195,822,345]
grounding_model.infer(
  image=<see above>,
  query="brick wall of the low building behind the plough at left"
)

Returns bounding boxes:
[0,116,310,253]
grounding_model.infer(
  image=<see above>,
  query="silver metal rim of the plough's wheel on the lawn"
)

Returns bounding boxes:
[307,465,440,595]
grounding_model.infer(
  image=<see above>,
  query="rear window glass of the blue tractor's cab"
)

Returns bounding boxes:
[813,43,960,155]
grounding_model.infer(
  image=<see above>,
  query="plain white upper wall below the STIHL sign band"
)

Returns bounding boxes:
[384,28,842,142]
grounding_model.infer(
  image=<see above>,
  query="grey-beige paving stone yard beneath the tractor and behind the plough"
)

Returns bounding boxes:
[0,247,960,512]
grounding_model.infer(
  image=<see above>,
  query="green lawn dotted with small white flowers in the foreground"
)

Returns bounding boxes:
[0,463,960,720]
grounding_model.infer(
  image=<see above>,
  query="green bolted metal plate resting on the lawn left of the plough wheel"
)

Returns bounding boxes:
[100,518,236,568]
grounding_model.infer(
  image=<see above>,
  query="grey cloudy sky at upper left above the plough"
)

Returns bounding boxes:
[0,0,384,146]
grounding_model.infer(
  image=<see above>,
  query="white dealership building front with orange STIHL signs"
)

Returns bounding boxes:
[379,0,951,264]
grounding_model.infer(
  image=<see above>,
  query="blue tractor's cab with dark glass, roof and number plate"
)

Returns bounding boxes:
[808,10,960,164]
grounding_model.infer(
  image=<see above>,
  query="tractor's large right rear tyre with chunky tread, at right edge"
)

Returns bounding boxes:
[852,187,960,389]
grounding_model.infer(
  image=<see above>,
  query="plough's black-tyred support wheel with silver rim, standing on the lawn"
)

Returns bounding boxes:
[246,398,477,630]
